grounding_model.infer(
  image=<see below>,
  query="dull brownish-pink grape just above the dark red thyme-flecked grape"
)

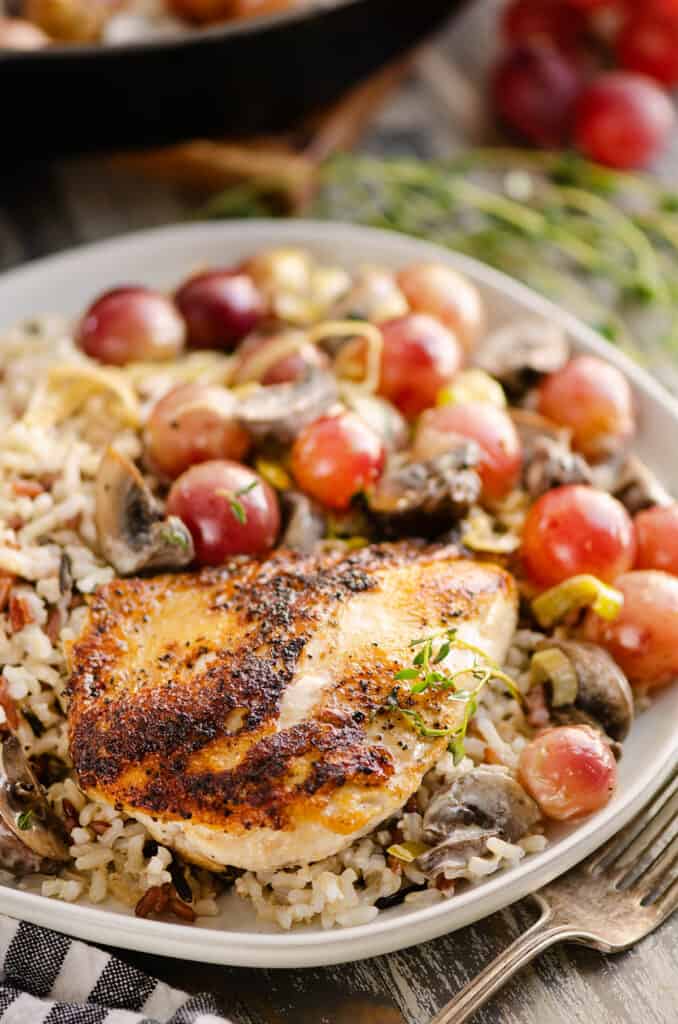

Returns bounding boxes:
[144,384,251,479]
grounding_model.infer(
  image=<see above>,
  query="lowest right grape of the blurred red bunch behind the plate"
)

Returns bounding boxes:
[575,72,675,170]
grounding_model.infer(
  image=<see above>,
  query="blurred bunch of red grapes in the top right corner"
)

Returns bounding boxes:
[492,0,678,169]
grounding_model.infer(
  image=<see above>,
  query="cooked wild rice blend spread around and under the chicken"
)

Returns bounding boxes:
[0,309,546,929]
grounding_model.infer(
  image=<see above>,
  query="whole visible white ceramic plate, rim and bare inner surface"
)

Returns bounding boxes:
[0,221,678,968]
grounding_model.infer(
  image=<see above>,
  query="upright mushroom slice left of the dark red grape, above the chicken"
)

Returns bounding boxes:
[95,447,195,575]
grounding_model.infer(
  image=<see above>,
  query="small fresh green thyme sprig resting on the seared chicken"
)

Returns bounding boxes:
[390,629,522,764]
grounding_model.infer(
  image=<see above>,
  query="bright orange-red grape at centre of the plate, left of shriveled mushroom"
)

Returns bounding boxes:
[292,412,386,509]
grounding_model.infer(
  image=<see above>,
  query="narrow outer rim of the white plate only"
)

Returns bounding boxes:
[0,219,678,968]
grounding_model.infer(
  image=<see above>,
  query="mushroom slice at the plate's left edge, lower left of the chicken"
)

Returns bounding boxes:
[0,731,70,874]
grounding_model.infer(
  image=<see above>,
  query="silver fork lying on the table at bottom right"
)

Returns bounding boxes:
[430,769,678,1024]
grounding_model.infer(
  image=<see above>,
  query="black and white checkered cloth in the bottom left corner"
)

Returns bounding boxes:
[0,915,228,1024]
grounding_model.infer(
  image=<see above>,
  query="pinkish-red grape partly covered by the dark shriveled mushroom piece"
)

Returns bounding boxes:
[413,401,522,501]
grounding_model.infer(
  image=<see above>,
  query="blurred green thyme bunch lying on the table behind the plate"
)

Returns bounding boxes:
[202,147,678,374]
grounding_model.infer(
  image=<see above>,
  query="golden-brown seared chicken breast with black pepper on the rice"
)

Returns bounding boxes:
[69,543,517,870]
